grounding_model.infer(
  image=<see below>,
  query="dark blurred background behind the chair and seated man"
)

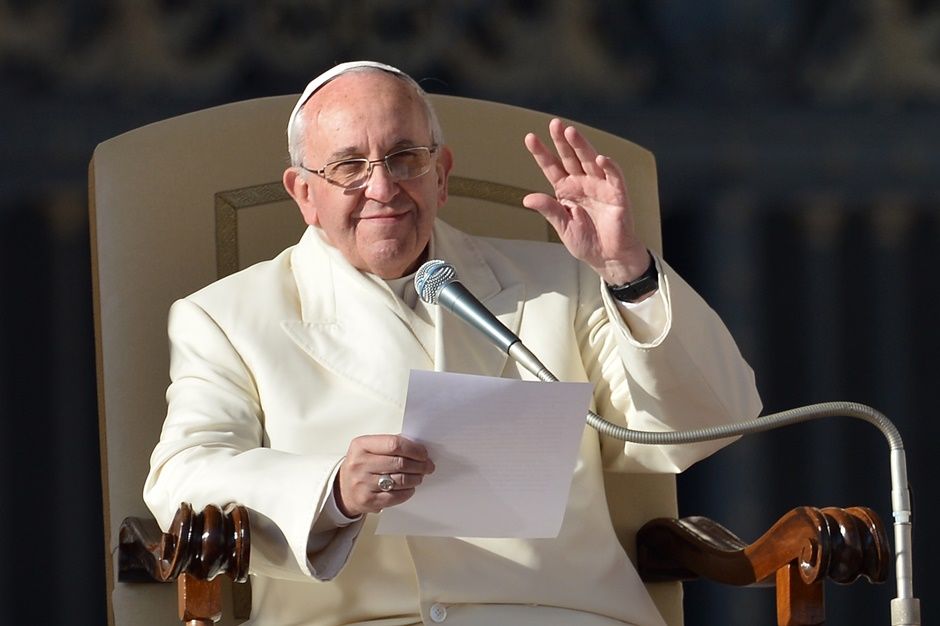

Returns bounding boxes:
[0,0,940,626]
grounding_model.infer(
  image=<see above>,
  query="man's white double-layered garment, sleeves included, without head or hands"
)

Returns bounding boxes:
[144,221,761,626]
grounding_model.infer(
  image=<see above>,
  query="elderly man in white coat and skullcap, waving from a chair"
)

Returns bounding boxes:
[145,62,760,626]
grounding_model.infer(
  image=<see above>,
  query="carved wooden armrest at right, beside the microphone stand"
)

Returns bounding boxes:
[637,507,890,626]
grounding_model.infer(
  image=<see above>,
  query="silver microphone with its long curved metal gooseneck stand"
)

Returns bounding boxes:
[414,260,921,626]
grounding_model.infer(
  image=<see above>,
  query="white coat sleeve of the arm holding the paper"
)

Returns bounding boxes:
[144,300,362,579]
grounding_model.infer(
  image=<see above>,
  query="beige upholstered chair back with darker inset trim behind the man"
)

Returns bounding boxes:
[89,96,681,626]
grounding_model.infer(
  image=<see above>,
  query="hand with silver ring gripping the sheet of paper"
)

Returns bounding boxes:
[334,435,434,517]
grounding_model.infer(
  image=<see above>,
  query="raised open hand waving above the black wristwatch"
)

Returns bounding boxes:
[522,118,650,285]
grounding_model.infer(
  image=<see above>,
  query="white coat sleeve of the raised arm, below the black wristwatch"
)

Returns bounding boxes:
[579,259,761,473]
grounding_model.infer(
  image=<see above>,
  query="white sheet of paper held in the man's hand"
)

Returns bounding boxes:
[376,370,592,538]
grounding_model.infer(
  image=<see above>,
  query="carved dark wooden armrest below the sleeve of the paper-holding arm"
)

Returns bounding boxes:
[118,502,251,626]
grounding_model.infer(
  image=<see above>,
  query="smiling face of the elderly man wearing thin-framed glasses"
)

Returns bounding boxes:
[284,72,451,278]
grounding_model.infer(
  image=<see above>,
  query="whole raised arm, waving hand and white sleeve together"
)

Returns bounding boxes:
[524,119,761,472]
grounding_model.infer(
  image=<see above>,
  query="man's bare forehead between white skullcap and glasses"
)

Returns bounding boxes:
[304,72,431,155]
